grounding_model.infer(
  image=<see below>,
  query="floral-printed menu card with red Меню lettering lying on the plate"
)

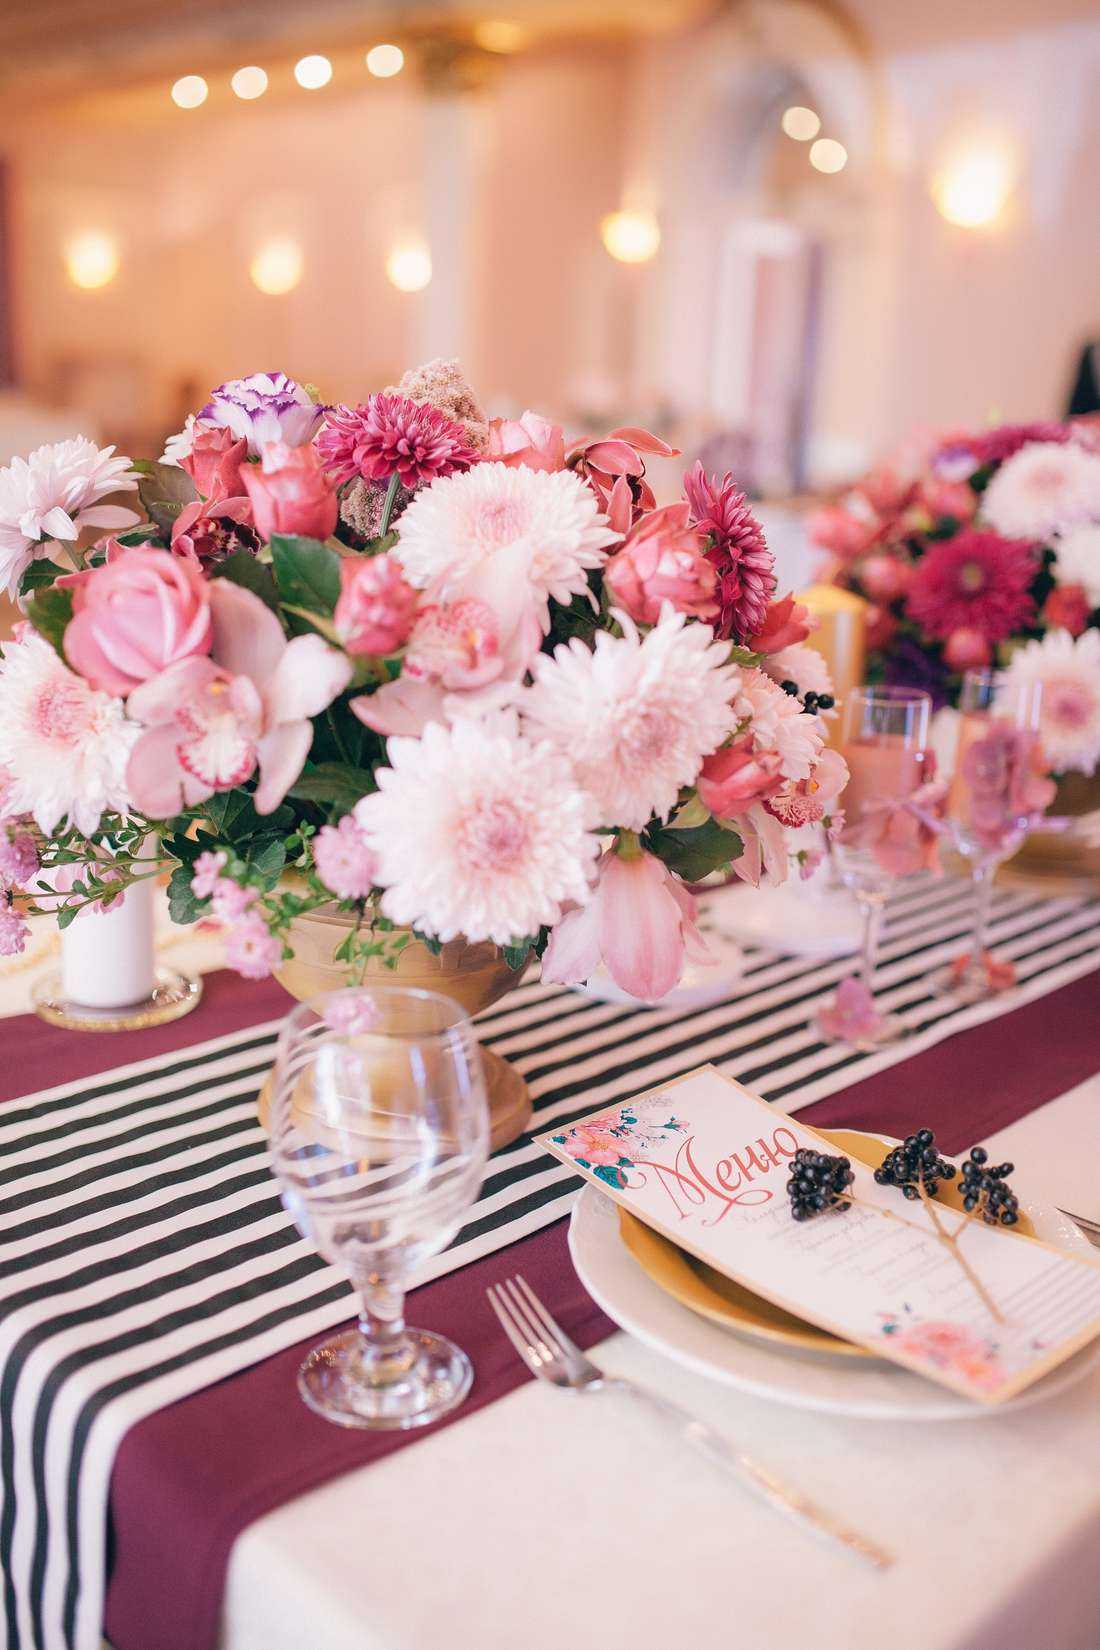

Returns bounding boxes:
[538,1066,1100,1404]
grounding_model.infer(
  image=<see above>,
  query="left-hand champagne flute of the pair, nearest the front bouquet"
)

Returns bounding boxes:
[826,686,932,1046]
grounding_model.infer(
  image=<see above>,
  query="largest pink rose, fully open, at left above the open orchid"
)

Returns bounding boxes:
[64,548,213,695]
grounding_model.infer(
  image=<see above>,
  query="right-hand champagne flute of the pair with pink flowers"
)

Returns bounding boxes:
[935,670,1054,1002]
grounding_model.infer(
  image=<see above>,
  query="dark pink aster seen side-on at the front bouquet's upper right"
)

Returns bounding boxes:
[684,462,775,642]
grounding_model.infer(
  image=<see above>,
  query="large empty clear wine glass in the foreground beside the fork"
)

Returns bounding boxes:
[270,985,488,1431]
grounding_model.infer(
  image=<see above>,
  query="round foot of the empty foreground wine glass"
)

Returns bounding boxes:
[299,1328,473,1432]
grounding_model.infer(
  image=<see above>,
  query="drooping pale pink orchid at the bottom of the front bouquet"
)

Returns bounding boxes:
[543,848,712,1003]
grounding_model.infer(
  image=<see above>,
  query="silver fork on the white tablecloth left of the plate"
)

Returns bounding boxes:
[487,1277,894,1569]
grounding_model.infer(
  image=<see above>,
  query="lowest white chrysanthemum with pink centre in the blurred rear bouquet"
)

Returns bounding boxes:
[1004,630,1100,774]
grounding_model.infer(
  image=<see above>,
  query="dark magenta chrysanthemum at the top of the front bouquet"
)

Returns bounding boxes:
[317,394,478,492]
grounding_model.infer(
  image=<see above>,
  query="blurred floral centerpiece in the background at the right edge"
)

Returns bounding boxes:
[811,421,1100,774]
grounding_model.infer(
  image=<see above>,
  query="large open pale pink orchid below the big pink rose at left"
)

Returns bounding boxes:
[127,579,353,818]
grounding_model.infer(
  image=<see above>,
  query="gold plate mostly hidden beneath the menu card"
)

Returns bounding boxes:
[618,1129,1034,1358]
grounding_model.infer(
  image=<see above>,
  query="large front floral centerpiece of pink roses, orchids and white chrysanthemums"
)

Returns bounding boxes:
[0,361,846,1000]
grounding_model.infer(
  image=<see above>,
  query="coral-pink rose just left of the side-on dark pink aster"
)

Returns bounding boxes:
[604,503,719,624]
